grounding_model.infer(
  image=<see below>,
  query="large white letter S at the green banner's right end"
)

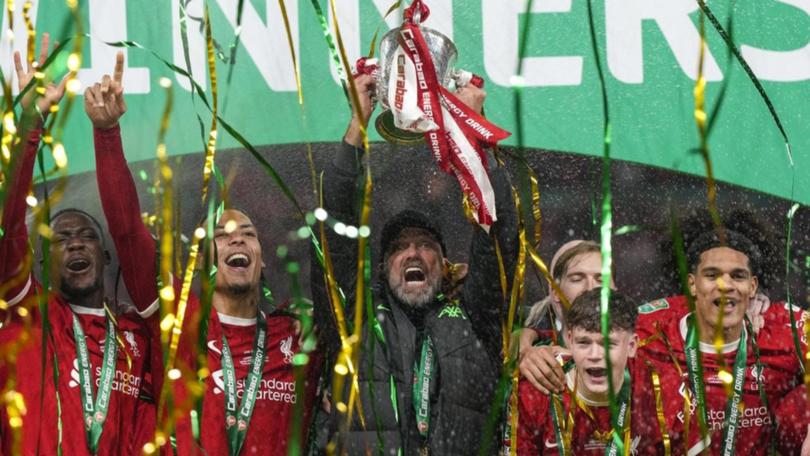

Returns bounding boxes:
[740,0,810,82]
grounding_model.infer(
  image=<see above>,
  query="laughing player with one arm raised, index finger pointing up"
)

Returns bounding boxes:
[85,53,318,456]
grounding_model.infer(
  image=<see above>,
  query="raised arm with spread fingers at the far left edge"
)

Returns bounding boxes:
[0,33,66,305]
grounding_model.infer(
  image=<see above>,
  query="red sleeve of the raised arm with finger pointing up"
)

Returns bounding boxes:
[93,125,158,317]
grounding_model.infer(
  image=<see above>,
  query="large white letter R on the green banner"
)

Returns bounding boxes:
[605,0,723,84]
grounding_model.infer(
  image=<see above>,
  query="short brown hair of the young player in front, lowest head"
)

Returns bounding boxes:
[565,288,638,332]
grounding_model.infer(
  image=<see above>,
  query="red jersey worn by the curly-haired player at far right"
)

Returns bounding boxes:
[637,296,808,455]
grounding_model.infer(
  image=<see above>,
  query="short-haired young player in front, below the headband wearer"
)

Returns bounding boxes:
[517,289,678,455]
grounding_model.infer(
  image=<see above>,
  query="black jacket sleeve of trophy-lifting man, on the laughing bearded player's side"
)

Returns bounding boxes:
[310,143,362,352]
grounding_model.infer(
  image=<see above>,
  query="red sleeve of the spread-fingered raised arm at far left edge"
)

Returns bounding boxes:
[0,128,41,305]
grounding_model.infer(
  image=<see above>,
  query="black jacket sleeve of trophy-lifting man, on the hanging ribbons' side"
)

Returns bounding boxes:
[462,162,519,366]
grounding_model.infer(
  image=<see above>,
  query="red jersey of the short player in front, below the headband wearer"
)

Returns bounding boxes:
[517,358,668,456]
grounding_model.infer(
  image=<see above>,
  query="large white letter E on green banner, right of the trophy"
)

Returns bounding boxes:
[480,0,582,86]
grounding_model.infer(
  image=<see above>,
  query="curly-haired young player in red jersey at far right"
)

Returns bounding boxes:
[638,230,808,455]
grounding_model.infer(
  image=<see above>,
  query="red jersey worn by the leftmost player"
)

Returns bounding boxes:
[2,283,150,455]
